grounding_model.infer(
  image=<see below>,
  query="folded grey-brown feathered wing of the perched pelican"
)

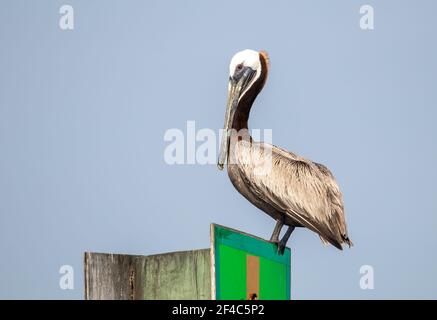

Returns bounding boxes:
[233,141,350,249]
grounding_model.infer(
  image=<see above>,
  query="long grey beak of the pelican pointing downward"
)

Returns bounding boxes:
[217,67,255,170]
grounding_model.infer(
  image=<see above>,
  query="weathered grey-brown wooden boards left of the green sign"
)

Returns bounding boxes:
[84,249,211,300]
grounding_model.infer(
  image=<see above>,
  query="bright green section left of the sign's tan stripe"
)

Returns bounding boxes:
[217,245,246,300]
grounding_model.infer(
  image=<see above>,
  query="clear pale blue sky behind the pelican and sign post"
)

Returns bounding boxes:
[0,0,437,299]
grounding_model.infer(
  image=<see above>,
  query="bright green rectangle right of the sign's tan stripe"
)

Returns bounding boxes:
[259,258,290,300]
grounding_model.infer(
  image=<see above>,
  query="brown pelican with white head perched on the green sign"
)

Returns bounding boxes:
[218,50,352,253]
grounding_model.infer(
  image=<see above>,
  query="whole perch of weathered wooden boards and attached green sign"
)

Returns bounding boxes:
[84,224,290,300]
